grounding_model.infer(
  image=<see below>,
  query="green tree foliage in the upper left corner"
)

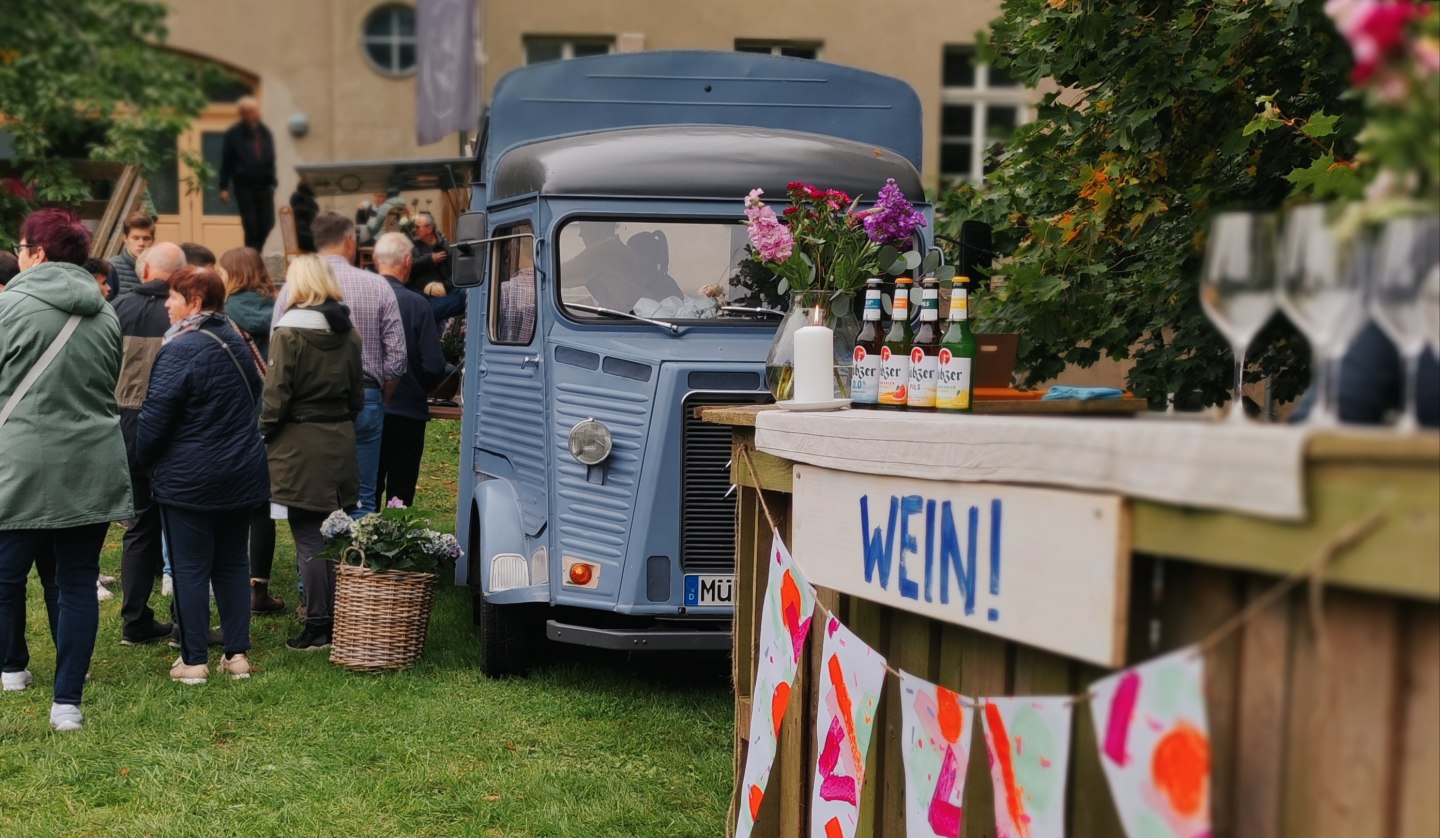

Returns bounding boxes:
[0,0,215,243]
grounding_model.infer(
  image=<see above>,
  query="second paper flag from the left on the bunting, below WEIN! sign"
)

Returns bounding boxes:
[811,618,886,838]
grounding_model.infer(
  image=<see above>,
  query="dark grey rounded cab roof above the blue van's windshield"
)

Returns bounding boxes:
[490,125,924,200]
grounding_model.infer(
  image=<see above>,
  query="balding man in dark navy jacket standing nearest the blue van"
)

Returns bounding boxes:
[374,233,445,507]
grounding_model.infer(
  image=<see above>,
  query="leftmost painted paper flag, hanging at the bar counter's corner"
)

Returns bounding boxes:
[734,533,815,838]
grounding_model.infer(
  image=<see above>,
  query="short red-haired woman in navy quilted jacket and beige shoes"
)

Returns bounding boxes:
[135,268,269,684]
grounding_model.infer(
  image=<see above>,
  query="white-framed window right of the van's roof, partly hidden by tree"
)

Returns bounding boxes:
[940,46,1030,181]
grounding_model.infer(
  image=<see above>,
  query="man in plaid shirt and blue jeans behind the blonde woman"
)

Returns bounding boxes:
[271,212,408,518]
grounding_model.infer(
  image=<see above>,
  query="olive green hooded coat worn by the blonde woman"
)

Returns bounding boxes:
[261,308,364,513]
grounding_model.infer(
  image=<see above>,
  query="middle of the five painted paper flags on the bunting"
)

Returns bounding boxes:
[900,672,973,838]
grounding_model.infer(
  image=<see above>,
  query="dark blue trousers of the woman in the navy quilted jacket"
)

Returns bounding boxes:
[161,507,251,667]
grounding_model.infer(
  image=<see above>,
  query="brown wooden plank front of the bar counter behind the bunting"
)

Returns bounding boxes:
[727,467,1440,838]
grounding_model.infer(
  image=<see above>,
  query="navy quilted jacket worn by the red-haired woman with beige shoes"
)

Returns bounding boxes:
[135,317,271,512]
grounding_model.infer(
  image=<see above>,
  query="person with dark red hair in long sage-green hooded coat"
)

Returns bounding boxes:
[0,209,134,730]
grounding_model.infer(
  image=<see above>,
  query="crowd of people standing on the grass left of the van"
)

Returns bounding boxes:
[0,205,449,730]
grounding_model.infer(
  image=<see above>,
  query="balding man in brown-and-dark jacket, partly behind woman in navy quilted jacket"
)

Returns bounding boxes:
[114,242,186,646]
